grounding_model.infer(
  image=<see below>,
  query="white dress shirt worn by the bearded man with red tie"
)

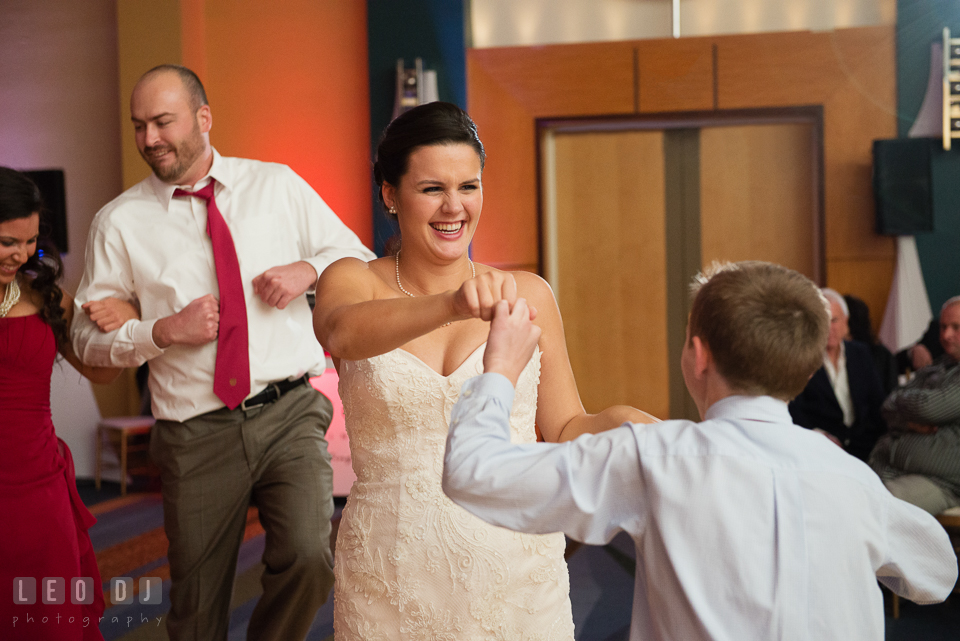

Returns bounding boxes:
[72,150,374,421]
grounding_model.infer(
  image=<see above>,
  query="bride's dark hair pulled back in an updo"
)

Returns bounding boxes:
[373,102,486,220]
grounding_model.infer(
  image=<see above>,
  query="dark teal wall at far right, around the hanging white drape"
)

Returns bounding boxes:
[897,0,960,314]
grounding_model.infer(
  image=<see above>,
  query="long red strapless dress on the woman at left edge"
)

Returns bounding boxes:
[0,315,104,641]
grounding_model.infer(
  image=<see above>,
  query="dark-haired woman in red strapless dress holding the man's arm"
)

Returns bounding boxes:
[0,167,136,641]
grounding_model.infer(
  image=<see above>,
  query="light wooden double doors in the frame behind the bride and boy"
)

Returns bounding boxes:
[541,122,822,419]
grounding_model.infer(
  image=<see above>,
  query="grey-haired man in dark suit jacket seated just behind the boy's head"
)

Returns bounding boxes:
[790,288,887,461]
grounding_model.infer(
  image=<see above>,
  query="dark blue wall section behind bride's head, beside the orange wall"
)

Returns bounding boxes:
[367,0,467,255]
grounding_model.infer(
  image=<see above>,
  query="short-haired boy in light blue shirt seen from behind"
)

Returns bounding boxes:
[443,263,957,641]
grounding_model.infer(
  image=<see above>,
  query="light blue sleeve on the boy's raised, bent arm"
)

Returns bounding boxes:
[443,374,644,545]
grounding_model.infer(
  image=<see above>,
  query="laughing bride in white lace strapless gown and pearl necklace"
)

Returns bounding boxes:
[314,103,652,641]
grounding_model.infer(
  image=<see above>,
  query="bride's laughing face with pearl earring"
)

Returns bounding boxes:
[383,143,483,262]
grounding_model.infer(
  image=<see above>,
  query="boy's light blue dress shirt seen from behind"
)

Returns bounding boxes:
[443,374,957,641]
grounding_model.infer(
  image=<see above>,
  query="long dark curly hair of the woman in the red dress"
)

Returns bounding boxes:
[0,167,68,347]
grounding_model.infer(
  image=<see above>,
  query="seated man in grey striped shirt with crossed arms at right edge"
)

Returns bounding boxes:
[870,296,960,514]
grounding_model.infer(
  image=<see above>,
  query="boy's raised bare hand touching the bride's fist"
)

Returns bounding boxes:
[483,298,540,387]
